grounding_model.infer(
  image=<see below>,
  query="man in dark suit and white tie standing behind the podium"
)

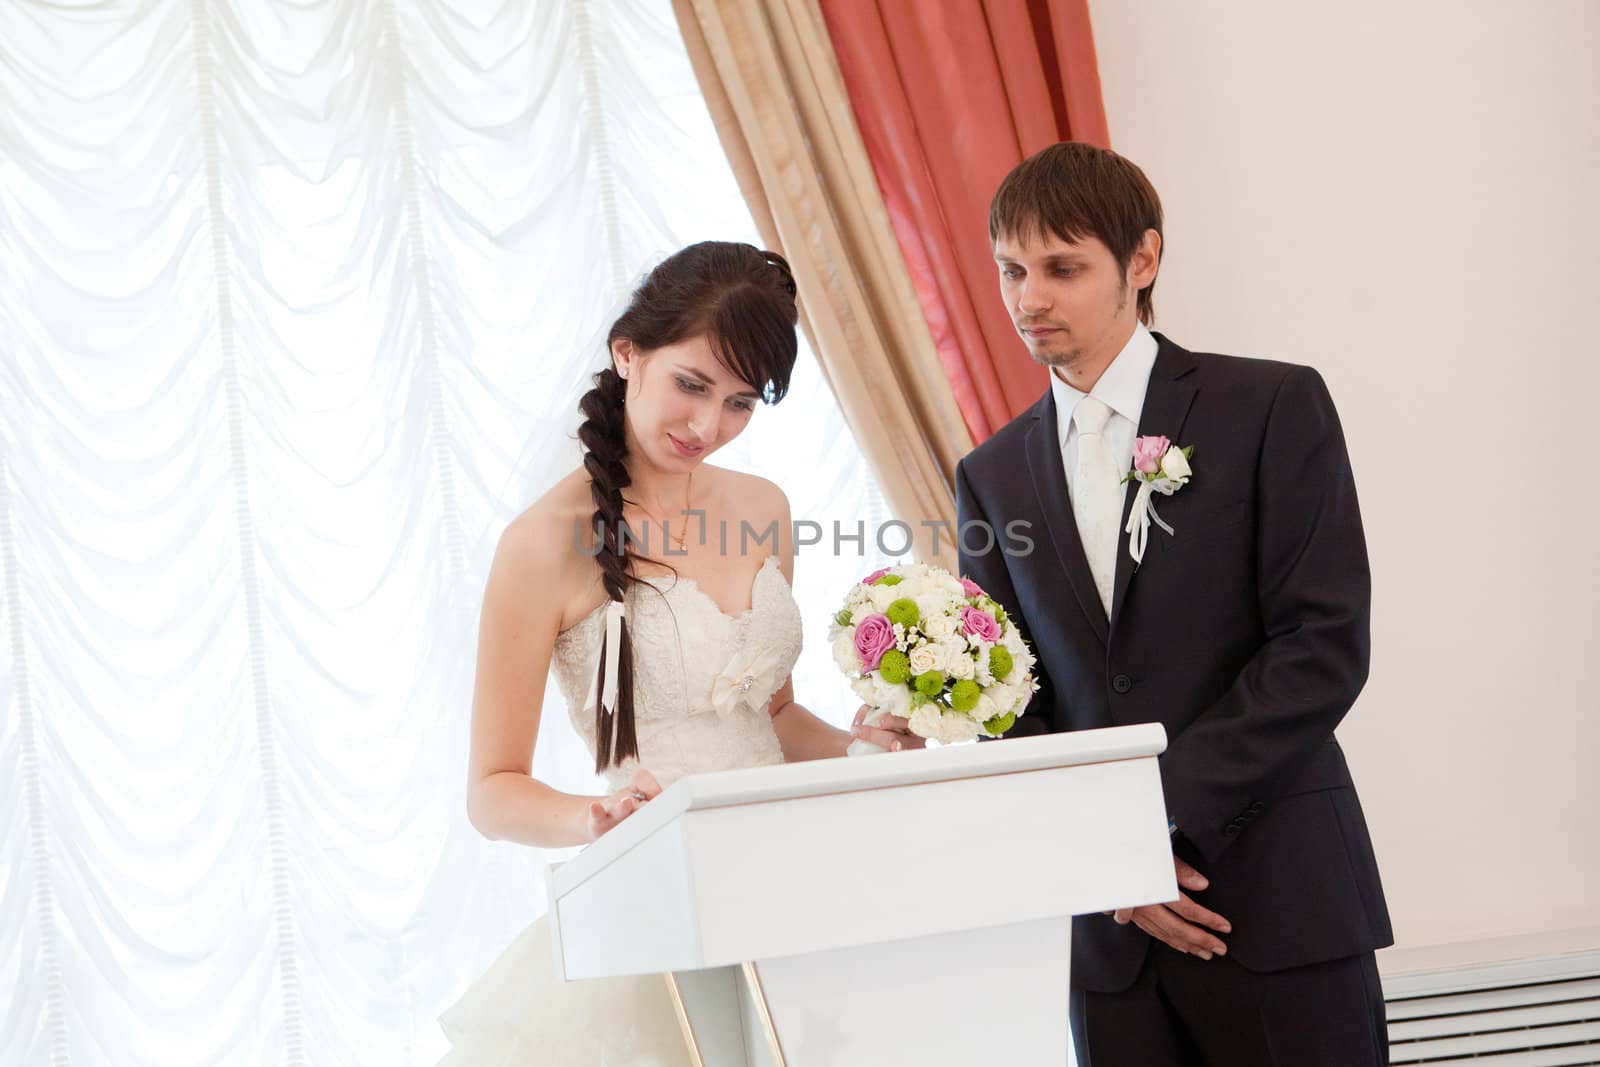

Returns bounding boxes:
[955,142,1392,1067]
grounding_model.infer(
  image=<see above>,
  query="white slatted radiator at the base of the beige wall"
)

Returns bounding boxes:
[1384,952,1600,1067]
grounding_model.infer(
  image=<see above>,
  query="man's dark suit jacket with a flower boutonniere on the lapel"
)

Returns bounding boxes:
[955,334,1392,992]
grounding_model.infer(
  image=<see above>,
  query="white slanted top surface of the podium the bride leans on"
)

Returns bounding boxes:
[550,723,1166,896]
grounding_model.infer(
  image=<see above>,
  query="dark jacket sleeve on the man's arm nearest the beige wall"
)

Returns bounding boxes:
[1160,366,1371,861]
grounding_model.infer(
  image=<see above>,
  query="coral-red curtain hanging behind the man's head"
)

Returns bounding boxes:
[819,0,1109,443]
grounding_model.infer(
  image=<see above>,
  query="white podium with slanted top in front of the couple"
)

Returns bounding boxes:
[549,725,1178,1067]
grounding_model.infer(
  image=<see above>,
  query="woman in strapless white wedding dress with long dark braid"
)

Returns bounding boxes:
[440,242,920,1067]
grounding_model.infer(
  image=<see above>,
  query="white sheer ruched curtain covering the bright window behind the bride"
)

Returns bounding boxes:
[0,0,883,1067]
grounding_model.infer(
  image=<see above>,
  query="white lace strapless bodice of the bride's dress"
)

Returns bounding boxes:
[554,555,802,789]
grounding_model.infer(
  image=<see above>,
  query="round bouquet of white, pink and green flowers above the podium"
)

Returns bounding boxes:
[829,563,1038,755]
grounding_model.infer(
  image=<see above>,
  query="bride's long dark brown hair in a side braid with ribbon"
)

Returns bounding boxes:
[578,242,798,773]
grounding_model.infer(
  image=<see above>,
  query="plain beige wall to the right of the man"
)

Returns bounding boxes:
[1091,0,1600,945]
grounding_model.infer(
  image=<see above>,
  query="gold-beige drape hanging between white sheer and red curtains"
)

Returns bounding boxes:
[674,0,982,571]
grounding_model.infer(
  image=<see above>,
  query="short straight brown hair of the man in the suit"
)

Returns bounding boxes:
[989,141,1165,325]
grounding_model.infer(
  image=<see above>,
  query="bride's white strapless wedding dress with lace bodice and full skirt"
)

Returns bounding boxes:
[440,557,802,1067]
